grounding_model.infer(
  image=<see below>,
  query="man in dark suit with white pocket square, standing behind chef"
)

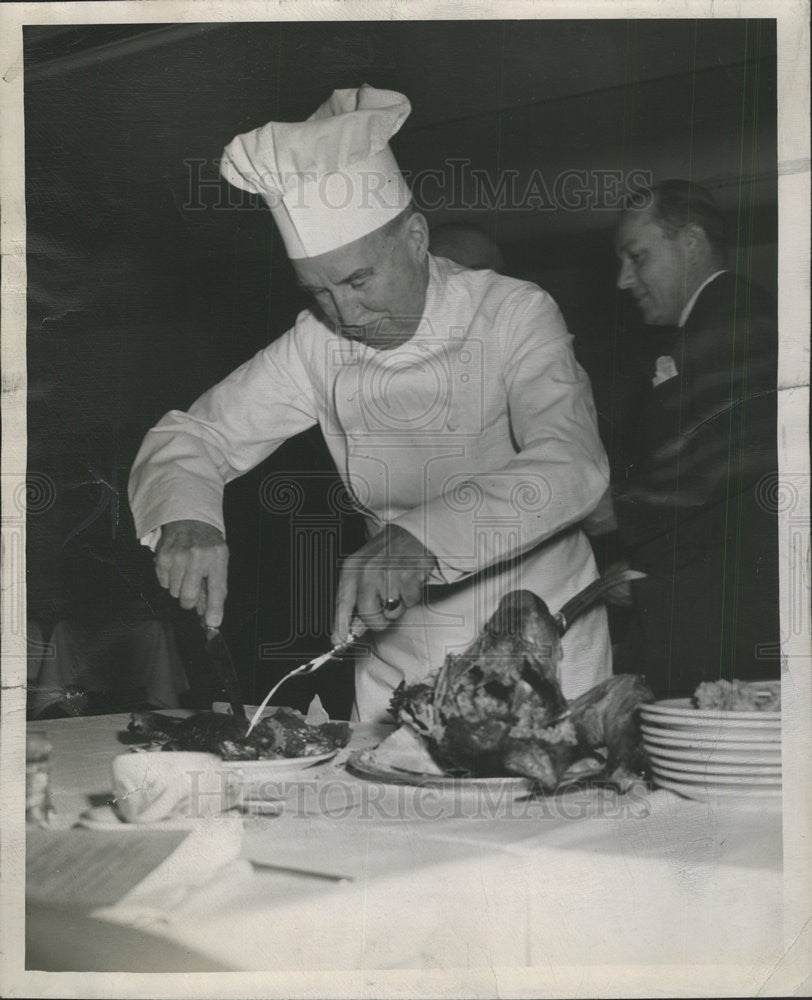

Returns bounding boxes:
[613,180,779,696]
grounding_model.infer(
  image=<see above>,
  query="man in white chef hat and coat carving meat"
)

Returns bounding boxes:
[130,85,611,721]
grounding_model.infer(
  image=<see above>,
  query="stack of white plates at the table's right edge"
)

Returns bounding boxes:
[640,698,781,799]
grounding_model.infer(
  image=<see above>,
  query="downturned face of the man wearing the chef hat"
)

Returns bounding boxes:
[292,212,428,350]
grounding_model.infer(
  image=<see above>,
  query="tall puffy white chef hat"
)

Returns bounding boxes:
[220,84,412,260]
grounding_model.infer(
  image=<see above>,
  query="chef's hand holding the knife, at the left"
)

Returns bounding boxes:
[155,521,228,628]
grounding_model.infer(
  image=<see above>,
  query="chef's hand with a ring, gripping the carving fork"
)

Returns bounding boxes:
[332,524,437,644]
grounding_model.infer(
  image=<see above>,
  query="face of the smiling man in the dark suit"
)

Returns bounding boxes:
[617,208,694,326]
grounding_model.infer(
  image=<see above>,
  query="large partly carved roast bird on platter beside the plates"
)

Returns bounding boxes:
[392,588,653,791]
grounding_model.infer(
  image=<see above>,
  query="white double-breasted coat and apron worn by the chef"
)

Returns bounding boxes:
[130,257,611,721]
